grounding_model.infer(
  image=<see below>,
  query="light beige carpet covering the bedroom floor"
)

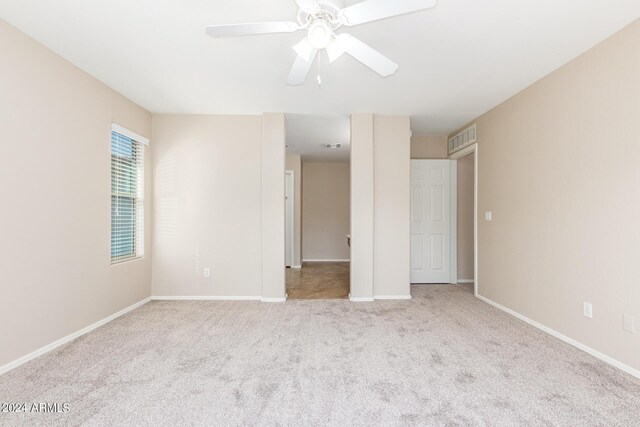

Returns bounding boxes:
[0,286,640,426]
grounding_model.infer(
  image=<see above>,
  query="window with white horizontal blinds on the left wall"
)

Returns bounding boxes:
[111,131,144,264]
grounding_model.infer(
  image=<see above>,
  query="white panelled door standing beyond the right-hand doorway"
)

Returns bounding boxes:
[411,160,455,283]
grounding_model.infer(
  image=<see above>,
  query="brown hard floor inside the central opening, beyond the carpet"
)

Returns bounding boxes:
[286,262,350,299]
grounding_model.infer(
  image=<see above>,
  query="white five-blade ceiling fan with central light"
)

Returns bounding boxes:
[207,0,437,86]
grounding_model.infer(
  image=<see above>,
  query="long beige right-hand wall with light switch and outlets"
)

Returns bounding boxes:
[464,21,640,370]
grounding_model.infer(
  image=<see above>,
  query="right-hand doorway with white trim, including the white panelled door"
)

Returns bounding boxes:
[411,144,478,294]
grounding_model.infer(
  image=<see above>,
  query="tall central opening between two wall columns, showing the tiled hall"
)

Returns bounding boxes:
[285,114,351,299]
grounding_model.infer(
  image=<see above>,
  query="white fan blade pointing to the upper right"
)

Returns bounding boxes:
[340,0,438,26]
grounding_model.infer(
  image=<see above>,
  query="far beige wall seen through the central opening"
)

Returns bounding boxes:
[302,162,350,261]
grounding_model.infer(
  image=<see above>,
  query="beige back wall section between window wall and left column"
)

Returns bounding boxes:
[153,115,264,296]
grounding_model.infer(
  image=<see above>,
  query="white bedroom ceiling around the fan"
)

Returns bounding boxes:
[0,0,640,134]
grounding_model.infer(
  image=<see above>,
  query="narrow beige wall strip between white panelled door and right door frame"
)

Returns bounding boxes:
[457,153,475,281]
